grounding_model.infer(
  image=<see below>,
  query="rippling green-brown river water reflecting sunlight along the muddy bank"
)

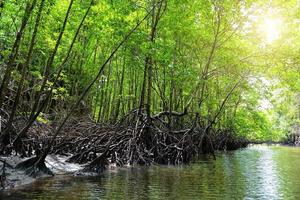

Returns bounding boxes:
[0,146,300,200]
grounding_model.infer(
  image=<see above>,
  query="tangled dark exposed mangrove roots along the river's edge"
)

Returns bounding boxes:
[0,110,248,176]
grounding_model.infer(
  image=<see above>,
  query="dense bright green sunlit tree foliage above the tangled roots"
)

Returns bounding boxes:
[0,0,300,140]
